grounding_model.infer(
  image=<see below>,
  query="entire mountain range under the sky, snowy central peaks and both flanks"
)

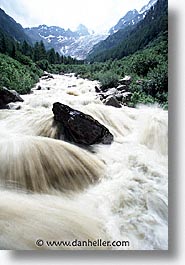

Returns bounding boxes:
[0,0,160,60]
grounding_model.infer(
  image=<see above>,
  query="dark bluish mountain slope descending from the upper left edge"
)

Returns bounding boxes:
[0,8,31,43]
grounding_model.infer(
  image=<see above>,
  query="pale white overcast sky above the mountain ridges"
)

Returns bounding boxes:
[0,0,149,33]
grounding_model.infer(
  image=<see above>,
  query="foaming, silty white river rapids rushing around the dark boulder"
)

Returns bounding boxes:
[0,74,168,250]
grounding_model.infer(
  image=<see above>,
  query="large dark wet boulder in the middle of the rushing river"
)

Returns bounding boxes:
[52,102,113,145]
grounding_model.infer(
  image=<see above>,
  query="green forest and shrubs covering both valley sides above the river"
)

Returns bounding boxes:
[0,0,168,109]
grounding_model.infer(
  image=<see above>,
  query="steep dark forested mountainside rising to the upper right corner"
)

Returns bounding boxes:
[87,0,168,61]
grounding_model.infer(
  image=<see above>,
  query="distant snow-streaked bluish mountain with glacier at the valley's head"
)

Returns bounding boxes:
[25,24,107,60]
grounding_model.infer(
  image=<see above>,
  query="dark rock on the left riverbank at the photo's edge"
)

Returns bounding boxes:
[0,87,24,109]
